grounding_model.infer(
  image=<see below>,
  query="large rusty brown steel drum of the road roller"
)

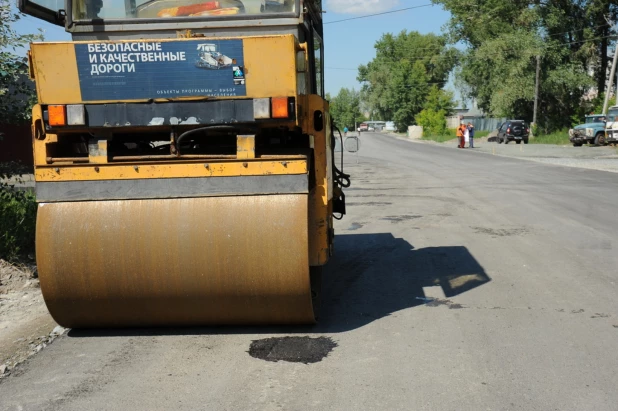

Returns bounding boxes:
[36,194,315,328]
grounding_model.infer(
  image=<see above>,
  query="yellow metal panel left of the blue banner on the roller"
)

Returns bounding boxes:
[31,43,82,104]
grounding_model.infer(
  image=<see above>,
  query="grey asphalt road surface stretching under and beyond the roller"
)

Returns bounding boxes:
[0,133,618,411]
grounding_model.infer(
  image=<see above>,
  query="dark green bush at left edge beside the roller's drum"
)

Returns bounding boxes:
[0,163,37,261]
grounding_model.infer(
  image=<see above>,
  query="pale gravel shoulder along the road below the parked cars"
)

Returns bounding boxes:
[388,134,618,173]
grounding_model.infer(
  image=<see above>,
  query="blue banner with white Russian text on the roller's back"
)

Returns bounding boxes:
[75,39,247,101]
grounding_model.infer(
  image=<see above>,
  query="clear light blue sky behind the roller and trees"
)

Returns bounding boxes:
[16,0,452,95]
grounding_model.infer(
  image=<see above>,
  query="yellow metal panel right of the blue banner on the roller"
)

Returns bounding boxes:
[243,35,296,98]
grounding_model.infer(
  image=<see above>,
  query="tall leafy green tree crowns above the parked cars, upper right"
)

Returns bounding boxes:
[434,0,618,130]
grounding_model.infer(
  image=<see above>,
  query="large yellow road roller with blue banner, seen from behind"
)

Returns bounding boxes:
[19,0,350,328]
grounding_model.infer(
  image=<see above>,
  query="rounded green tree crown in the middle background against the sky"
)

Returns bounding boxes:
[357,31,458,131]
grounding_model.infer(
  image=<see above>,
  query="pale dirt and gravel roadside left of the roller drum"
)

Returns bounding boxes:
[0,259,65,380]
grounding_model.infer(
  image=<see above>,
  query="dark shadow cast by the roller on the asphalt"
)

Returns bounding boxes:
[69,233,491,337]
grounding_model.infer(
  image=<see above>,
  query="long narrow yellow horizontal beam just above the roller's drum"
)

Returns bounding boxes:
[35,160,307,181]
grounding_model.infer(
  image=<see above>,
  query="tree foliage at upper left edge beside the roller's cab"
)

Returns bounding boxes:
[0,0,42,123]
